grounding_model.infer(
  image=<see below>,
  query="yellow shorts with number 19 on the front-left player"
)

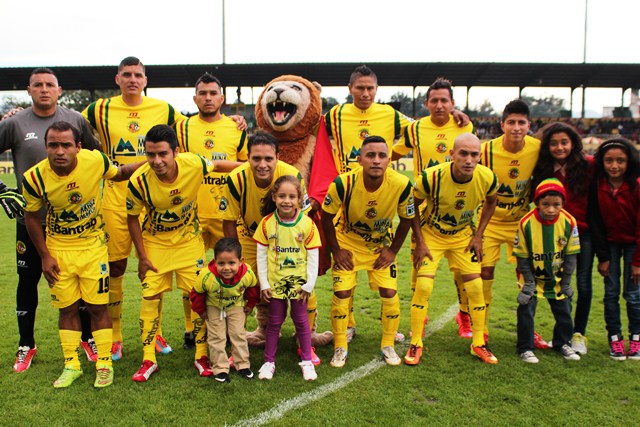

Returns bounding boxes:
[49,246,109,308]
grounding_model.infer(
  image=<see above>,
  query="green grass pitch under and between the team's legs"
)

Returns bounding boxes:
[0,175,640,426]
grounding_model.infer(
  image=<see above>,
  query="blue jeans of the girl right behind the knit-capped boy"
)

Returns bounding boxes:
[573,231,594,335]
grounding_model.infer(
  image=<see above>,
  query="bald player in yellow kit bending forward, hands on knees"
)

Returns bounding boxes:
[404,133,498,365]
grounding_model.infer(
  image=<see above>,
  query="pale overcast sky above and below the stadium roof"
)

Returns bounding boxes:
[0,0,640,116]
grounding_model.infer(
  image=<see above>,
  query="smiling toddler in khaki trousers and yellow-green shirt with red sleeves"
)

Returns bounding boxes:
[190,237,260,383]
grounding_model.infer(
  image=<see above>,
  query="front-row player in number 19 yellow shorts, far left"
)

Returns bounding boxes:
[22,122,141,388]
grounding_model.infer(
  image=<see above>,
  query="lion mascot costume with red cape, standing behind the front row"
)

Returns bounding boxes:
[247,75,337,347]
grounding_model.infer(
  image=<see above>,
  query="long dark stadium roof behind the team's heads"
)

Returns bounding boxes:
[0,62,640,90]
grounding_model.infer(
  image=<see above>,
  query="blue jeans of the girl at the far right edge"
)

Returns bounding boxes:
[604,244,640,337]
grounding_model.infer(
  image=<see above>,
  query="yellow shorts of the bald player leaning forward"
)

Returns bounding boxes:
[418,228,480,276]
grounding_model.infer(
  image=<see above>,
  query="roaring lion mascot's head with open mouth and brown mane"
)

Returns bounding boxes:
[256,75,322,142]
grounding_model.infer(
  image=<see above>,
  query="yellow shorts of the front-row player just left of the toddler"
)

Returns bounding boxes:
[142,237,205,297]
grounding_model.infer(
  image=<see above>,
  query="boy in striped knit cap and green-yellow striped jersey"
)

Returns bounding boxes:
[513,178,580,363]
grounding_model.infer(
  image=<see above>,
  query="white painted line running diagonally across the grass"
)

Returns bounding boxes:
[232,304,458,427]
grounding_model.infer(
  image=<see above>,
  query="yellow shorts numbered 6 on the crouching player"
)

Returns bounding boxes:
[331,252,398,292]
